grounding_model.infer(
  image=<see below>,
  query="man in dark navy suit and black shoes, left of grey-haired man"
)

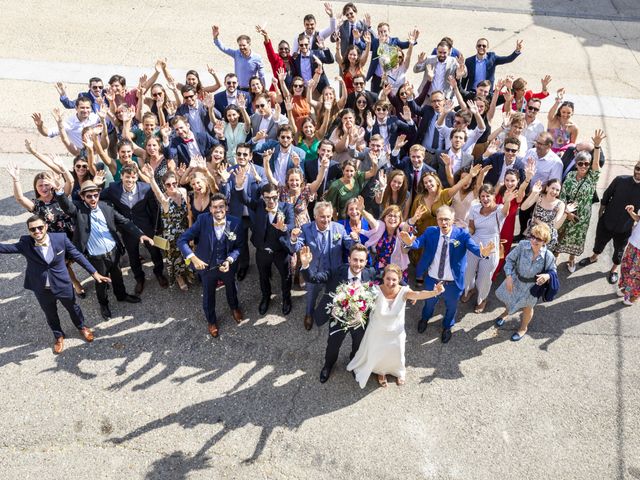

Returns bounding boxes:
[231,175,294,315]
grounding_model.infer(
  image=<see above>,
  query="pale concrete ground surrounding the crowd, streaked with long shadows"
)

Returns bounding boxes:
[0,0,640,480]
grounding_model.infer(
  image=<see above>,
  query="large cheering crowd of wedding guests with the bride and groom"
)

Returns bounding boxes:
[0,3,640,386]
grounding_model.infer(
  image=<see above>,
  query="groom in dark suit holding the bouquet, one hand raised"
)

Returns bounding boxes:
[300,243,375,383]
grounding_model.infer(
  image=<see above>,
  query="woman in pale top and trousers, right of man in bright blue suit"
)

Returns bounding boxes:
[461,184,516,313]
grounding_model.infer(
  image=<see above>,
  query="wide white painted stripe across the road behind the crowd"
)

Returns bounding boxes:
[0,58,640,120]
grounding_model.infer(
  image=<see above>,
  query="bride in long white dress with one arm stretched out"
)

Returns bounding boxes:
[347,264,444,388]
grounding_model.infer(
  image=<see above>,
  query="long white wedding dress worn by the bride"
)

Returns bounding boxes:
[347,286,409,388]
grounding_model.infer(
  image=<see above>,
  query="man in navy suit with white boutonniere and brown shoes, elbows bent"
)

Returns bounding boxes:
[178,193,246,338]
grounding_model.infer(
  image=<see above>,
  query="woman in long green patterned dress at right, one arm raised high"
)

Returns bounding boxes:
[553,130,606,273]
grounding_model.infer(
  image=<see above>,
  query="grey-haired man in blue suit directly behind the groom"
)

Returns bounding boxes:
[290,202,357,330]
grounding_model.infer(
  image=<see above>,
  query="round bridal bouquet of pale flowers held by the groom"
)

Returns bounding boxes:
[327,282,376,330]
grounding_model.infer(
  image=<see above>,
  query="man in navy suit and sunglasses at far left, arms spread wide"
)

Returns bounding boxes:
[0,215,110,354]
